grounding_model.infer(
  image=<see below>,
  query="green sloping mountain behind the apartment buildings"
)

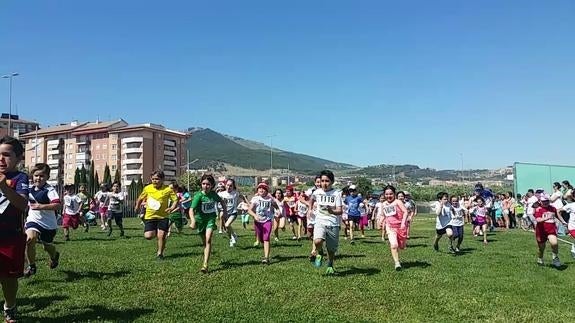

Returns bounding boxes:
[188,128,357,174]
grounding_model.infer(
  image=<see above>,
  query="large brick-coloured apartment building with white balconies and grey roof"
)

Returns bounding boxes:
[22,119,187,186]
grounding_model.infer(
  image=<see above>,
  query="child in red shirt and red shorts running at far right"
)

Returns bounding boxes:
[533,194,566,268]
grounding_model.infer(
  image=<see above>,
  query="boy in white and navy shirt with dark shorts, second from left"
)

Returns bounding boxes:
[24,163,61,277]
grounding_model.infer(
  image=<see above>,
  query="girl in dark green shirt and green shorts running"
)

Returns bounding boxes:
[190,174,228,274]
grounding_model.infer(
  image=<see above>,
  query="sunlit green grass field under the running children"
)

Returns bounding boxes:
[13,217,575,322]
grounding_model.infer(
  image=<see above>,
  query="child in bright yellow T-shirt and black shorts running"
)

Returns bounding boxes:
[134,170,178,260]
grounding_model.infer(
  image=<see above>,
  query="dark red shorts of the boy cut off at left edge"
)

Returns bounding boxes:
[0,235,26,278]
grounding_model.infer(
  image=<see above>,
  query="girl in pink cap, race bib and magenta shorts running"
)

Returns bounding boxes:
[248,183,280,265]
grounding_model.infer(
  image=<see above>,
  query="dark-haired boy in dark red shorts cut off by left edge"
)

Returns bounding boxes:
[0,136,28,322]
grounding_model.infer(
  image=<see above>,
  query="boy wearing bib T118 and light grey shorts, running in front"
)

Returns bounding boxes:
[308,170,343,275]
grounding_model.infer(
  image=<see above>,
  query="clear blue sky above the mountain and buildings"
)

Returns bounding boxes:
[0,0,575,169]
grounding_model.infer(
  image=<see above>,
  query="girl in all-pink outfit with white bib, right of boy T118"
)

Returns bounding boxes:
[381,185,407,271]
